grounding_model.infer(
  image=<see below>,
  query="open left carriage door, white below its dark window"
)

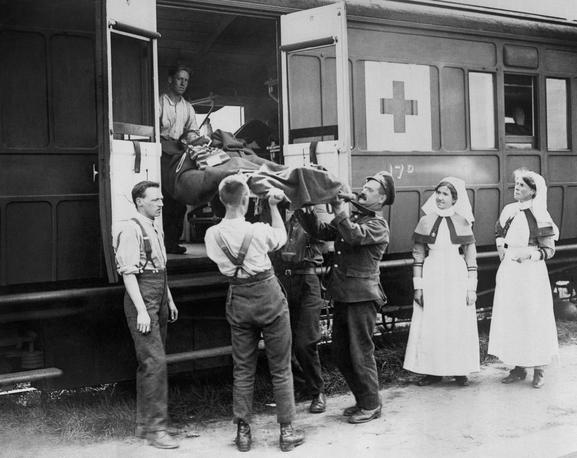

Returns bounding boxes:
[95,0,161,281]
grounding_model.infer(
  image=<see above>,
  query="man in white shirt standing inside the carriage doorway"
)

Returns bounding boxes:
[159,66,199,254]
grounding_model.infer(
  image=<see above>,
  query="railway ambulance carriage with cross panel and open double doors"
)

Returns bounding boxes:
[0,0,577,389]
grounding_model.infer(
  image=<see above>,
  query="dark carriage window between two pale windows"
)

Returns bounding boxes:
[505,74,536,149]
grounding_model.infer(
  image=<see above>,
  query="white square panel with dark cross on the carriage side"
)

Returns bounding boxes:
[365,61,432,151]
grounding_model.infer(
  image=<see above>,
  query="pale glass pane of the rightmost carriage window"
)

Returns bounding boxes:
[546,78,569,150]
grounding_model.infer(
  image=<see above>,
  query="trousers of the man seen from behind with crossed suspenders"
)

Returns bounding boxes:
[226,275,295,423]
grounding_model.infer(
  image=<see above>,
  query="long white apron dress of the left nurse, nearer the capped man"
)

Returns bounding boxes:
[403,219,479,376]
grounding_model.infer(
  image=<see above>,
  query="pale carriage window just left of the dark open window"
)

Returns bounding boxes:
[469,72,495,149]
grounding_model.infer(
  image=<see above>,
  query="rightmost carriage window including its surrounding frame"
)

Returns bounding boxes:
[545,77,571,151]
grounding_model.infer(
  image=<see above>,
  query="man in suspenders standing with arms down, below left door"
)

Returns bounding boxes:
[115,181,179,449]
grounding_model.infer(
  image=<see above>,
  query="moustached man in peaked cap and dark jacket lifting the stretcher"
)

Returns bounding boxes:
[297,172,395,423]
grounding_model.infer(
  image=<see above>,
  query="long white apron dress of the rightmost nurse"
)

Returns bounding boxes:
[489,211,559,367]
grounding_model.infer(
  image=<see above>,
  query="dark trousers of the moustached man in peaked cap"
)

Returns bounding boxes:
[332,301,381,410]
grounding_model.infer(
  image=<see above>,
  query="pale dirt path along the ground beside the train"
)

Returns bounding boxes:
[9,345,577,458]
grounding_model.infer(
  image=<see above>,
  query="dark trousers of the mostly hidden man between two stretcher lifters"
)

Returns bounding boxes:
[281,274,324,396]
